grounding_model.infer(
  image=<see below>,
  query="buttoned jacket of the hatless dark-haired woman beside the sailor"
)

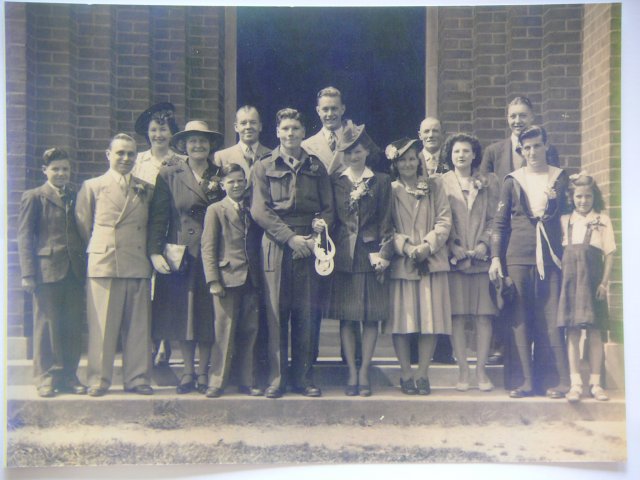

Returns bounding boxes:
[442,171,500,273]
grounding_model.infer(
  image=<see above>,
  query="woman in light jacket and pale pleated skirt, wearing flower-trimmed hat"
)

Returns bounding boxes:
[385,138,451,395]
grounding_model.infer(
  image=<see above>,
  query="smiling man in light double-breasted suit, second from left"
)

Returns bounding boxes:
[76,133,153,397]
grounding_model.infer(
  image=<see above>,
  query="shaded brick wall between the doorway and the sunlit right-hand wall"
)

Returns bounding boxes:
[438,5,582,166]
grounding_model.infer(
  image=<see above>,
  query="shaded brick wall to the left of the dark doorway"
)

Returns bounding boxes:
[5,3,224,335]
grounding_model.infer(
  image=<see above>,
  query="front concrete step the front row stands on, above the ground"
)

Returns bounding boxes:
[7,386,625,430]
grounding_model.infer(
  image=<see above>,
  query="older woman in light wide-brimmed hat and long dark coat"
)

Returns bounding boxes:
[147,120,224,393]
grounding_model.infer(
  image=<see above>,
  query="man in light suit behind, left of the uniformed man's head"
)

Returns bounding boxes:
[213,105,271,180]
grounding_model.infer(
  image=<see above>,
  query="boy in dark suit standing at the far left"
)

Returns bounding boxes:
[18,148,87,397]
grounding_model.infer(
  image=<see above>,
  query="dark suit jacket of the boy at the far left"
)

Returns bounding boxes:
[18,182,87,283]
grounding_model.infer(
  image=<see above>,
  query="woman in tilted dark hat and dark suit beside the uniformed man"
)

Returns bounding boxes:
[329,125,393,397]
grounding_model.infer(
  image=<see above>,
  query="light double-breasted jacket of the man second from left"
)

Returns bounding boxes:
[76,172,153,278]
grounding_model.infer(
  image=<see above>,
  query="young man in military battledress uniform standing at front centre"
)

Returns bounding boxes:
[251,108,334,398]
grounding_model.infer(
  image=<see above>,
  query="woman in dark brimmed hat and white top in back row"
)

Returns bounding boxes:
[131,103,185,185]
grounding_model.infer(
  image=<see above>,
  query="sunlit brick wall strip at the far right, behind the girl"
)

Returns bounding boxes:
[581,4,622,340]
